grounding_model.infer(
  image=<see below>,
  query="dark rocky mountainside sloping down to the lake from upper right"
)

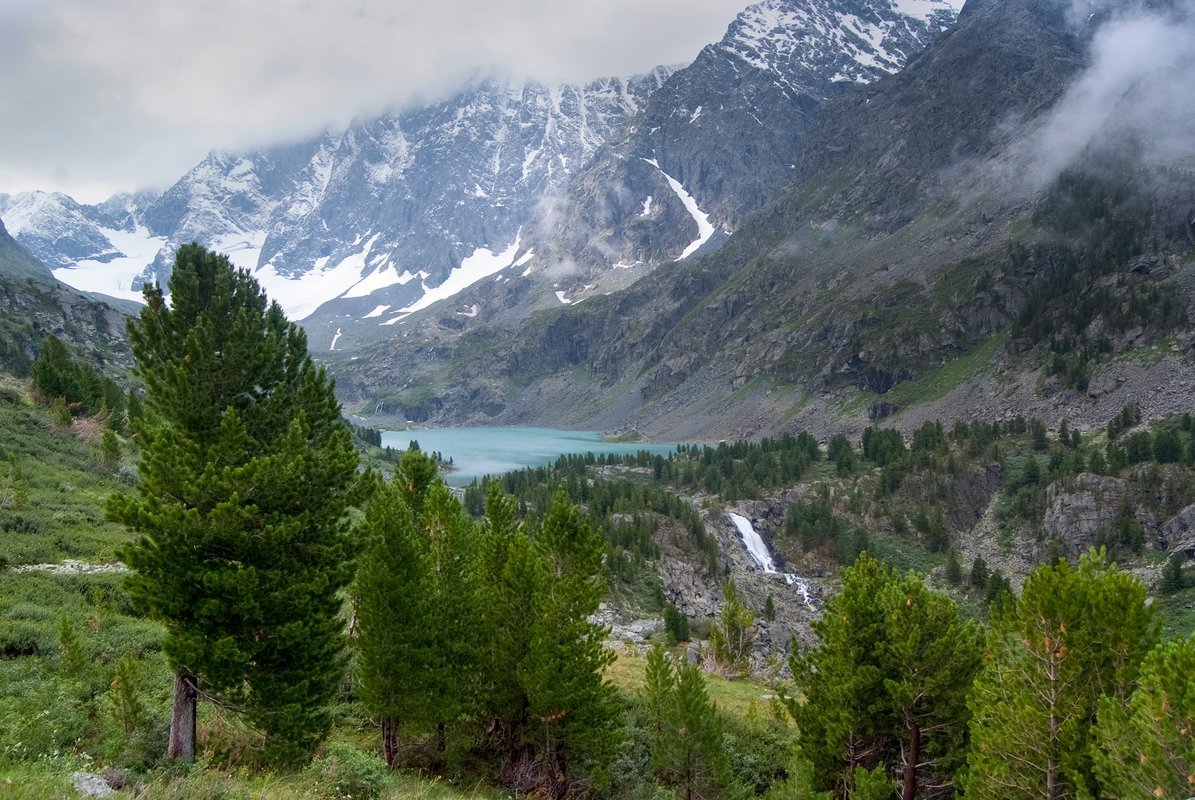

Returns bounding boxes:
[325,0,1195,439]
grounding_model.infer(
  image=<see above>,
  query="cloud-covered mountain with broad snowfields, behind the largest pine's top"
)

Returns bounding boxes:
[0,67,672,319]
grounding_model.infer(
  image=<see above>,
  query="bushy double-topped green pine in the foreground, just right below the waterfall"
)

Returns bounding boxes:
[789,554,980,800]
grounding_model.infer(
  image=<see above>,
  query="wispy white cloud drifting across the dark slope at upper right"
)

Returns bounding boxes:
[1018,1,1195,190]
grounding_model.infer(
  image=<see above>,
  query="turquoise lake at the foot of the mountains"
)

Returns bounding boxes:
[381,428,676,487]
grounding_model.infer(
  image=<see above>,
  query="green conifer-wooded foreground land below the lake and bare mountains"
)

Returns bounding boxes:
[0,245,1195,800]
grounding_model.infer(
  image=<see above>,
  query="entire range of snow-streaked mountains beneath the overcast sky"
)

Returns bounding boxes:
[0,0,962,349]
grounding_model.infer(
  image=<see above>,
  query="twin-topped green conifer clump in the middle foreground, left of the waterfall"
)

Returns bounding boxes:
[483,484,619,789]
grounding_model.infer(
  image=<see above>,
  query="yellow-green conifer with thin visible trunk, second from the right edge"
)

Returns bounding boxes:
[966,552,1158,800]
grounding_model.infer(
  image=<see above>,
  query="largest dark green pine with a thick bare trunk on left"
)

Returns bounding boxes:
[109,244,357,762]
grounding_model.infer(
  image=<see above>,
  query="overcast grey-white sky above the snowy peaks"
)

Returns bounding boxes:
[0,0,748,202]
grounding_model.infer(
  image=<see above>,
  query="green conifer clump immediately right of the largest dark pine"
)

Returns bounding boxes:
[353,450,482,767]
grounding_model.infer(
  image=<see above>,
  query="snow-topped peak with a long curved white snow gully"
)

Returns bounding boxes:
[531,0,963,285]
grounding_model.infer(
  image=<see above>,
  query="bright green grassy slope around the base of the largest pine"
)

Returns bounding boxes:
[0,375,792,800]
